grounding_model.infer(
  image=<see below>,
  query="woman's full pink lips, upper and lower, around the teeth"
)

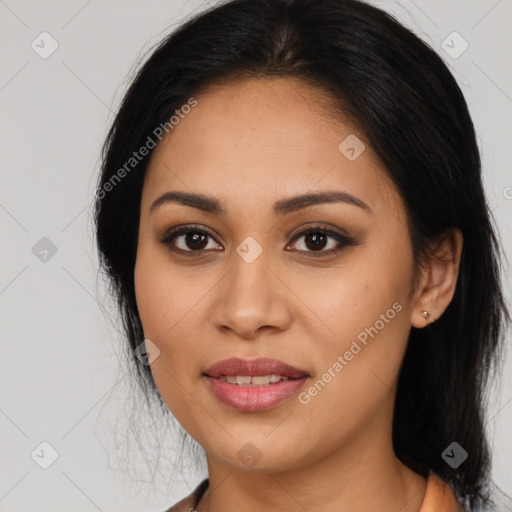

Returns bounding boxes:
[205,358,309,411]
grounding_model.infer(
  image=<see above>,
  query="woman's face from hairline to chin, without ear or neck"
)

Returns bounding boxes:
[135,79,426,471]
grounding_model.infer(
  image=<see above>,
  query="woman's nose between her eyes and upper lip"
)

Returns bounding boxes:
[211,251,292,340]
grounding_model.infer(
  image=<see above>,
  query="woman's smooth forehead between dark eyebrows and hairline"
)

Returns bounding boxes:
[144,79,398,217]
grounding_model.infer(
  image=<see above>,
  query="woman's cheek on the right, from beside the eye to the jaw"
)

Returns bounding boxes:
[298,233,412,412]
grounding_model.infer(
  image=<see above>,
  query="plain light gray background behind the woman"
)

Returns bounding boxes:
[0,0,512,512]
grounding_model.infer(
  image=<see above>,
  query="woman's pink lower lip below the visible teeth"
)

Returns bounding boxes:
[206,376,308,411]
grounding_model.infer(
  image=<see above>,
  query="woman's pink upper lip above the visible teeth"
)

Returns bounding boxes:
[204,357,309,379]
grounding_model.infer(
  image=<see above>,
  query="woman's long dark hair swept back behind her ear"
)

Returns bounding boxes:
[94,0,510,509]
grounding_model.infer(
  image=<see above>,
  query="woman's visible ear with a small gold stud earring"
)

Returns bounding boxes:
[411,228,463,328]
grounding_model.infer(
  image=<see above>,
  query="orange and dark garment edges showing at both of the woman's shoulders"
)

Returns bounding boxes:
[165,471,464,512]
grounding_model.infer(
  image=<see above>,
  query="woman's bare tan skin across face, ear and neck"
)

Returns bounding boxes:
[134,78,462,512]
